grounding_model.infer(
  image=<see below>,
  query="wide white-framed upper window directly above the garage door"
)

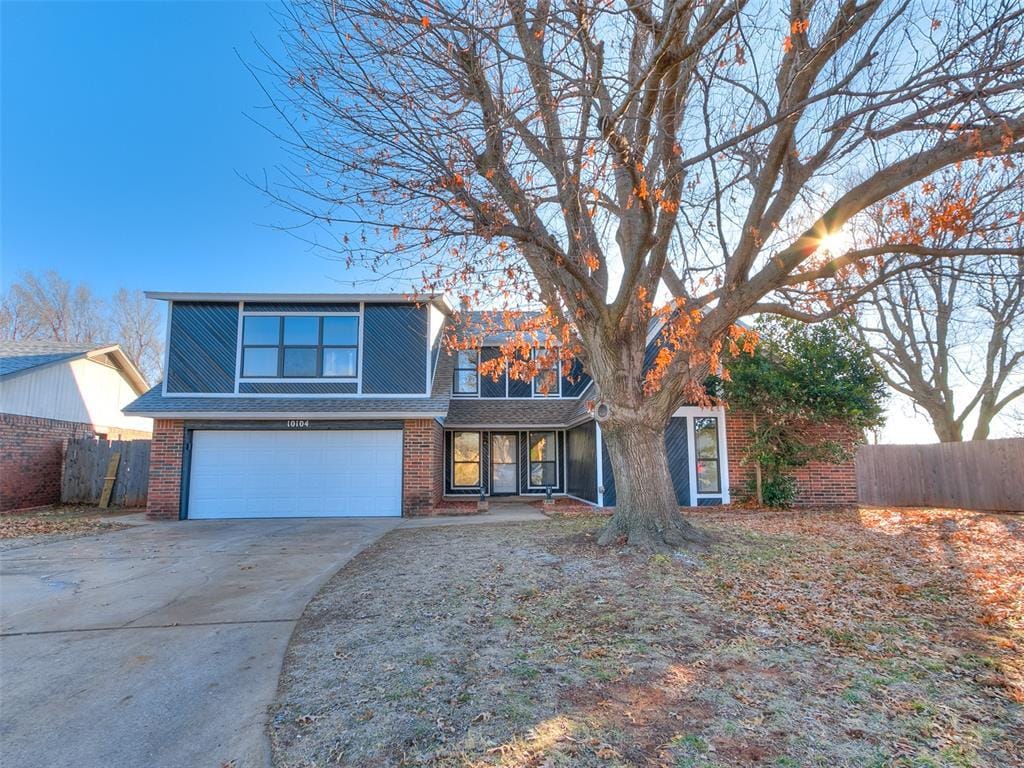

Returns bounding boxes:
[242,314,359,379]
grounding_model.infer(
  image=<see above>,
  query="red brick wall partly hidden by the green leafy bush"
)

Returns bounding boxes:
[725,410,858,507]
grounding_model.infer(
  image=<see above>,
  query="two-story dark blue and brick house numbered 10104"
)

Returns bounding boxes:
[125,293,856,519]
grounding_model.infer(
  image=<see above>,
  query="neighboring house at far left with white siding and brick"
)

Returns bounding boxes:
[0,341,153,512]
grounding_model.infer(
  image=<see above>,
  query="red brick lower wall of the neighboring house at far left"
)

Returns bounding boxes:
[0,414,150,512]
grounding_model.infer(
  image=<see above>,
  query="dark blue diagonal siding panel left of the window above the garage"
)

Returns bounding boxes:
[167,302,239,392]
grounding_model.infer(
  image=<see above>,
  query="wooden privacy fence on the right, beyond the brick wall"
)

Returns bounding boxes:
[857,437,1024,512]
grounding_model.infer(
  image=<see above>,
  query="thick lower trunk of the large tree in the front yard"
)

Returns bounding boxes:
[598,419,708,552]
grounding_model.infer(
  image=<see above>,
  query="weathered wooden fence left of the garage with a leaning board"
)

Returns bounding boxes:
[60,437,150,507]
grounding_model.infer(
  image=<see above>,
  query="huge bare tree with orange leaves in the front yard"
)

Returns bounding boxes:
[261,0,1024,549]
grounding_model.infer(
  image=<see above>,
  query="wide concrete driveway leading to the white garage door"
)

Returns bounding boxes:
[0,518,399,768]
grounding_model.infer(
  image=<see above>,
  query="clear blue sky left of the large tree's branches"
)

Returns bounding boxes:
[0,0,385,295]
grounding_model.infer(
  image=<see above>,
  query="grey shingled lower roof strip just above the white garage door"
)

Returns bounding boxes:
[124,385,447,419]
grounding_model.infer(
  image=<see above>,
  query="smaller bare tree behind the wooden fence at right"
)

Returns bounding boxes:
[855,162,1024,442]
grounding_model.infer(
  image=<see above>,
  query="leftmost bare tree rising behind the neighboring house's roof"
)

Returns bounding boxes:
[2,270,109,344]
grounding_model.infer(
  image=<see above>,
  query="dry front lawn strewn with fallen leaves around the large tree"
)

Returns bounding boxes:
[270,509,1024,768]
